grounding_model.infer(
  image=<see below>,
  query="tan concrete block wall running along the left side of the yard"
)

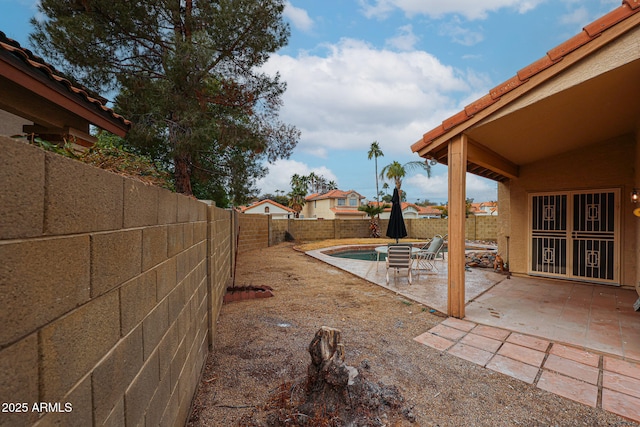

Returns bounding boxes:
[0,137,233,426]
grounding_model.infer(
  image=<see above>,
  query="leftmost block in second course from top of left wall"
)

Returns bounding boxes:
[0,236,90,347]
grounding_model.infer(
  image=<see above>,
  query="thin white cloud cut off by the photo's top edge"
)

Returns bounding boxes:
[360,0,545,20]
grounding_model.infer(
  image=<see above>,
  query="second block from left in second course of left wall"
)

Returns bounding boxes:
[91,230,142,298]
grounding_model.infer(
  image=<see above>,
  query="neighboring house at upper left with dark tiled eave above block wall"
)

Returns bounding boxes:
[0,31,131,146]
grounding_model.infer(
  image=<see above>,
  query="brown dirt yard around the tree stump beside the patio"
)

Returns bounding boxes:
[188,243,636,427]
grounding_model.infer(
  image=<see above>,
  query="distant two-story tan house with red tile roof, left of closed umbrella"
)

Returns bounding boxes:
[300,190,368,219]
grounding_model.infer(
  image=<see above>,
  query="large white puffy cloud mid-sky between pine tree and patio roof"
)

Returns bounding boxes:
[264,39,476,157]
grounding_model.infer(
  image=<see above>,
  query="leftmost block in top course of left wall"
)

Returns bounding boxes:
[0,136,45,239]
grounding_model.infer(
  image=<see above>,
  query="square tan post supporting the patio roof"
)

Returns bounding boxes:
[447,134,467,319]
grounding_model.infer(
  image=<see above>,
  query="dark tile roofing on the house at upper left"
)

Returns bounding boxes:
[0,31,131,134]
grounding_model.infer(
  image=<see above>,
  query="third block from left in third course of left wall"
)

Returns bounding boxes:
[120,270,156,336]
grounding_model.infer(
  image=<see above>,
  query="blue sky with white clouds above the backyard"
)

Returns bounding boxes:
[0,0,622,202]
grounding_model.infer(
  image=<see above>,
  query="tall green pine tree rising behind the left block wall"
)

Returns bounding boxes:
[31,0,300,201]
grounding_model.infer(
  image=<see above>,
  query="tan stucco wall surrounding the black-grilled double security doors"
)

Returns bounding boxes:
[498,135,640,287]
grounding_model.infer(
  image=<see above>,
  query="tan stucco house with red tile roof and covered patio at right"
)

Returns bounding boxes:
[412,0,640,317]
